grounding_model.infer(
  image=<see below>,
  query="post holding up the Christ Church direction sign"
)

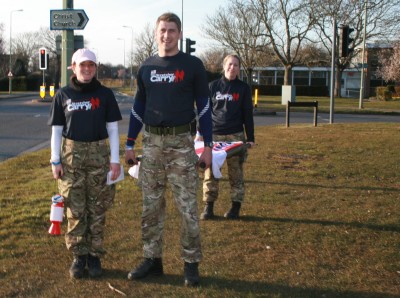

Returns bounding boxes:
[60,0,74,87]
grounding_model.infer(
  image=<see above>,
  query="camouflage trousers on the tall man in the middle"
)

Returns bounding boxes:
[139,132,202,262]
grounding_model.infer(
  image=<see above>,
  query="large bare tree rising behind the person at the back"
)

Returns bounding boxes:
[204,0,315,85]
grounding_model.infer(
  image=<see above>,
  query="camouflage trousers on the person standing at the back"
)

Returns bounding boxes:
[203,133,247,203]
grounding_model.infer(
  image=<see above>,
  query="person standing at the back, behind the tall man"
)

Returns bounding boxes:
[196,55,254,220]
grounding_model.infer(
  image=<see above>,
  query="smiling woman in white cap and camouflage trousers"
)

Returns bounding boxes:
[48,49,122,278]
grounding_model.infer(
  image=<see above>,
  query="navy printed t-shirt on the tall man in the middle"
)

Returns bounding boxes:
[135,52,208,127]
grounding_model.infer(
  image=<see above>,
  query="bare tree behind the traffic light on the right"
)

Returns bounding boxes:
[309,0,400,96]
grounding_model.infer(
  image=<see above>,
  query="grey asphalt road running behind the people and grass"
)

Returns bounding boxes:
[0,93,400,162]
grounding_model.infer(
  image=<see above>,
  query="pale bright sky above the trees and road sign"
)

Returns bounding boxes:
[0,0,228,64]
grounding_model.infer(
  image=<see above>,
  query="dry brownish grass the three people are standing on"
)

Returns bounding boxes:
[0,124,400,297]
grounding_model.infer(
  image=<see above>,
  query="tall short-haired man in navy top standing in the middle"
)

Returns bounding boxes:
[125,13,212,286]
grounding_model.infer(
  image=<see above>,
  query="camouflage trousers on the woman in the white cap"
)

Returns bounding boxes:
[58,139,115,256]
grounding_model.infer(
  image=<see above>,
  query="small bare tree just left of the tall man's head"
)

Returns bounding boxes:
[131,23,157,66]
